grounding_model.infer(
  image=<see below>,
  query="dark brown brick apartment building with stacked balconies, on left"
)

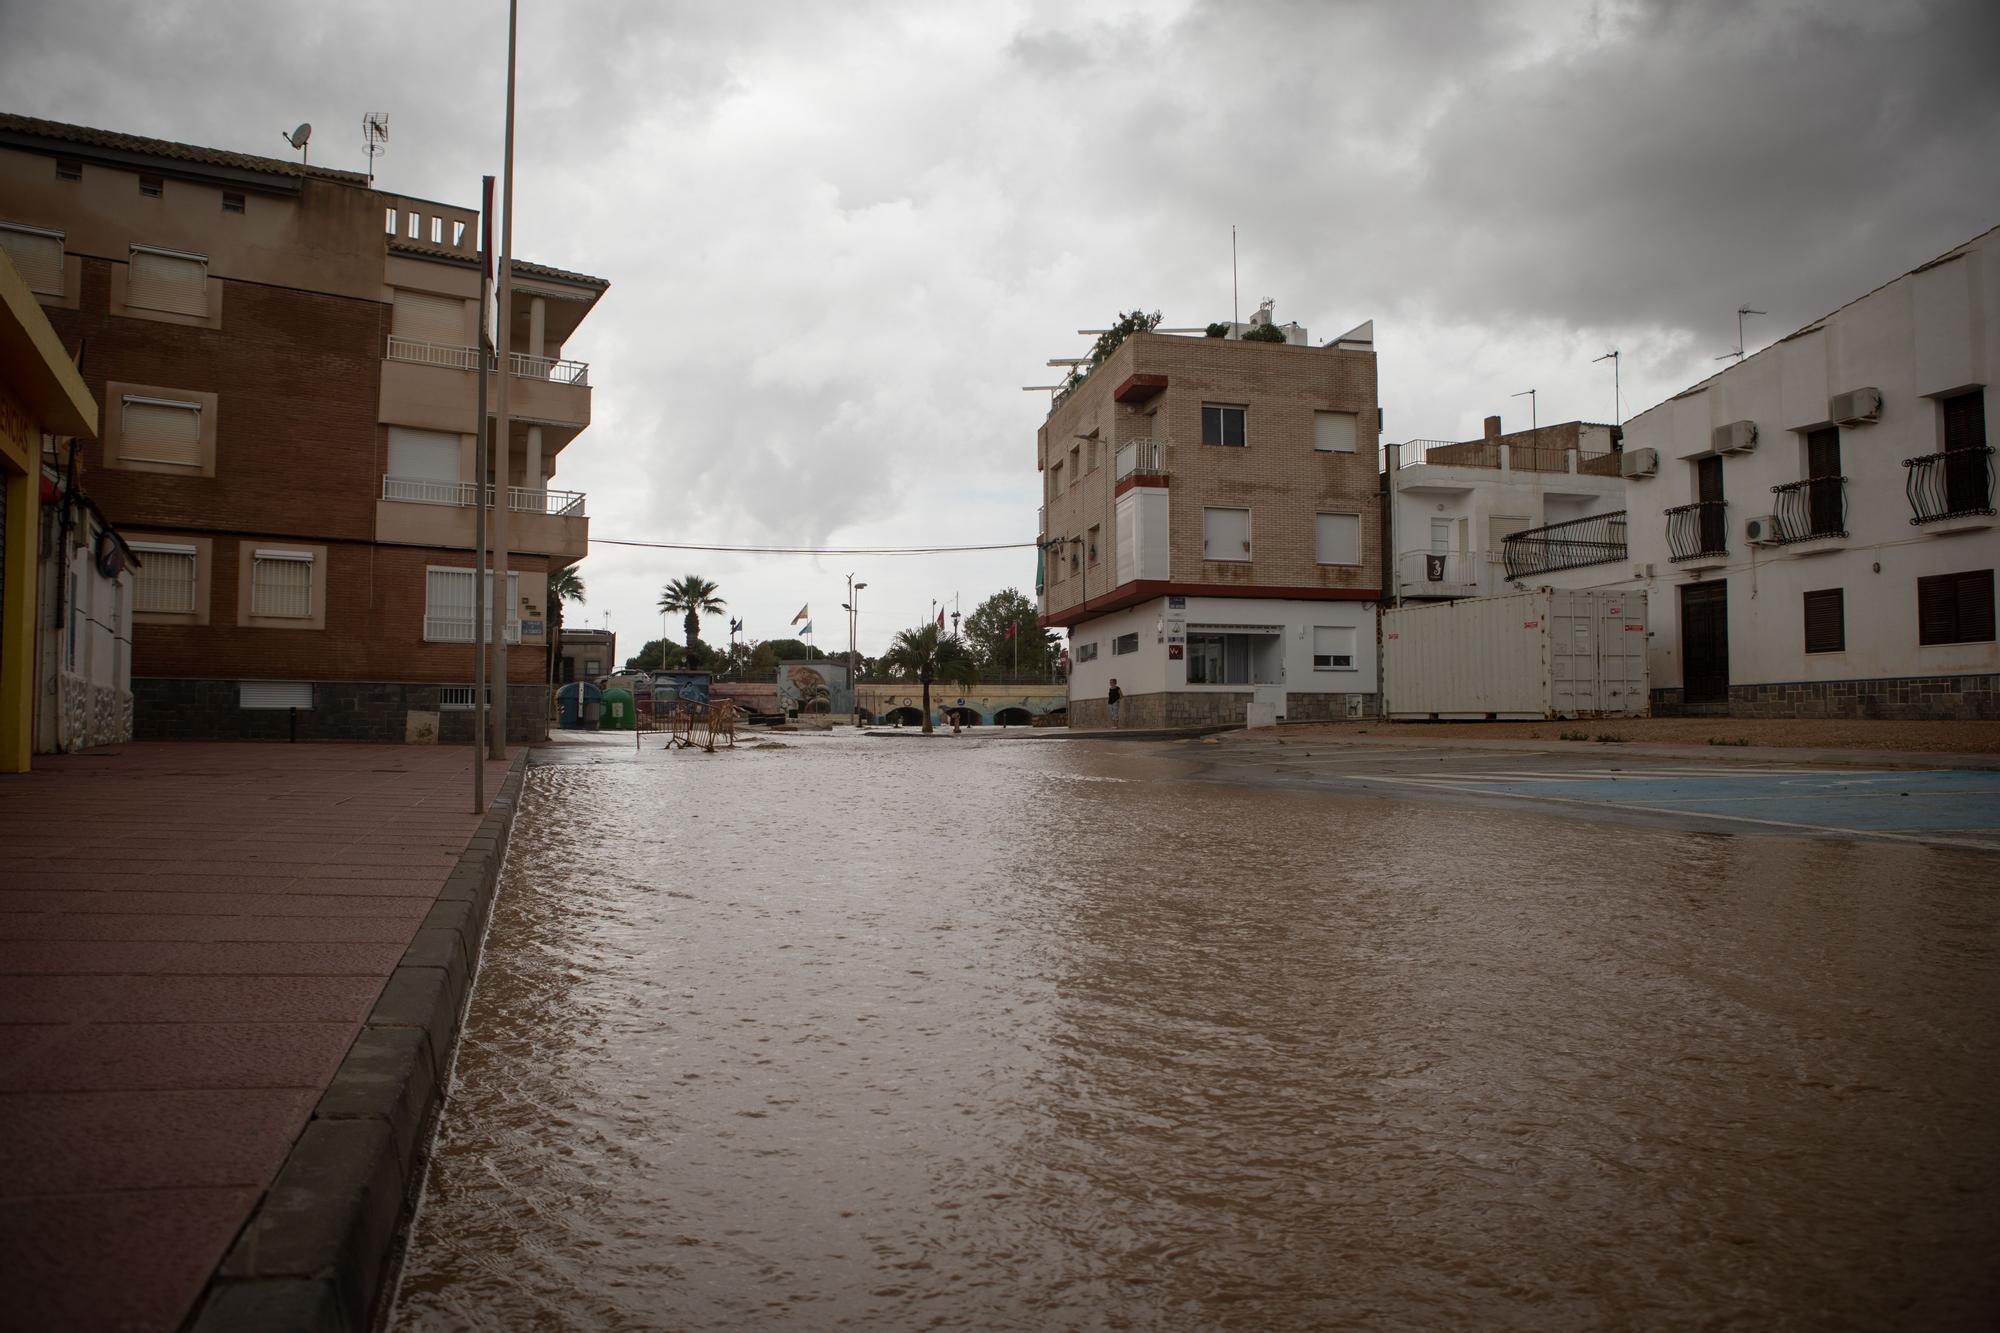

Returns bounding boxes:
[0,116,608,741]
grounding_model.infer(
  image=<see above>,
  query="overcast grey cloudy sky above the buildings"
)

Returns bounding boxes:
[0,0,2000,654]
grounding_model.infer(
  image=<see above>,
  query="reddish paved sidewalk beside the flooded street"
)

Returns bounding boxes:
[0,745,506,1329]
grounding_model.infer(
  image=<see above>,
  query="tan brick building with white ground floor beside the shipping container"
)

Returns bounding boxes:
[1036,312,1382,727]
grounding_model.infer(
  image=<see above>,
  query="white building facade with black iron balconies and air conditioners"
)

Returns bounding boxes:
[1624,228,2000,719]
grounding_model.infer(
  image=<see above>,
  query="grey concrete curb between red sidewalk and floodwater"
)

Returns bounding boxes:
[186,747,528,1333]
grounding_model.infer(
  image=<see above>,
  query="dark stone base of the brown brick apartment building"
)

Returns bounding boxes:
[132,677,548,745]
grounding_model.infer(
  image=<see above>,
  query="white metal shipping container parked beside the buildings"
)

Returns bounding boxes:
[1382,588,1652,721]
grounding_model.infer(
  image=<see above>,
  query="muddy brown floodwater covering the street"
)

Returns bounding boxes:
[396,737,2000,1331]
